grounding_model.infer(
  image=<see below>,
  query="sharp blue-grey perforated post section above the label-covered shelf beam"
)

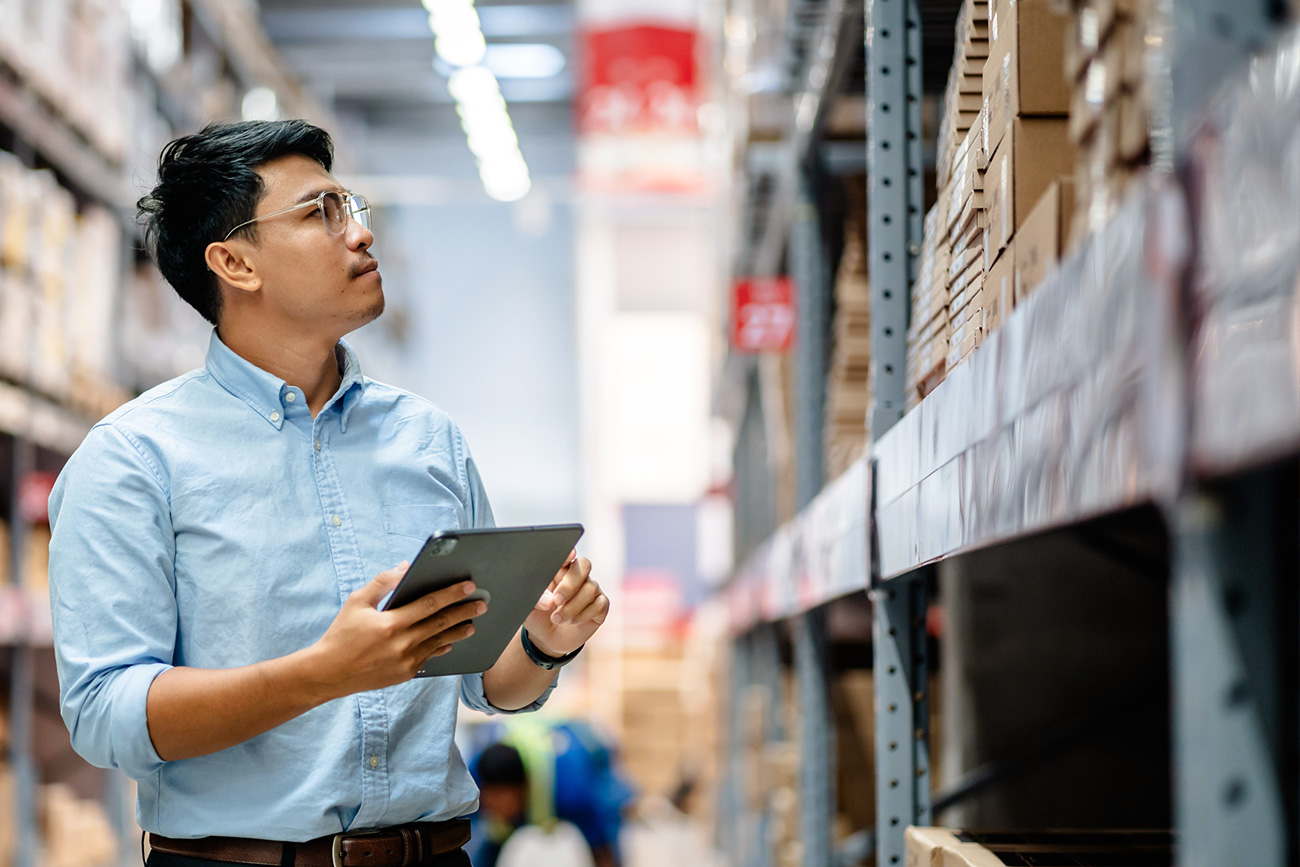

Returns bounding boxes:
[866,0,924,439]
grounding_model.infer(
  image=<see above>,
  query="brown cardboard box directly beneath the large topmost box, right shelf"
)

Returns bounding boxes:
[984,117,1075,265]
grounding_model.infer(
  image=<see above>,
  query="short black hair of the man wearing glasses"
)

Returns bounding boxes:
[135,121,334,325]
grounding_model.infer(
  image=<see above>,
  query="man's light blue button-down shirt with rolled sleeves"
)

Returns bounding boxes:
[49,333,554,840]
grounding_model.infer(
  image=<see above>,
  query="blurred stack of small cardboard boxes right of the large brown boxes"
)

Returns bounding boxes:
[1065,0,1161,250]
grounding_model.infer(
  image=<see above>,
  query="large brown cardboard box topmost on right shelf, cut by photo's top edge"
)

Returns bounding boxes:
[984,0,1070,153]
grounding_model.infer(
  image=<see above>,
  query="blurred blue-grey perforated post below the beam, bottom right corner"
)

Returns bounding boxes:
[1170,474,1300,867]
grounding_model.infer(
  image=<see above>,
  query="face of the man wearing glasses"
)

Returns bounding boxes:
[236,155,384,337]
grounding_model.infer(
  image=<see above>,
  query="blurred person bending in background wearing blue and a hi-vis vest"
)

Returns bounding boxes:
[471,719,633,867]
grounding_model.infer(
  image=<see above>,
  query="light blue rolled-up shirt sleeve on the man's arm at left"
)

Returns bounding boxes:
[49,425,177,780]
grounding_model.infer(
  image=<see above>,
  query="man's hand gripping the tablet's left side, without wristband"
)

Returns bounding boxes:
[313,563,488,697]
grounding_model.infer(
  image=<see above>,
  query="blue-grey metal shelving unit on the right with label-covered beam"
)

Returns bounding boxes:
[722,0,1300,867]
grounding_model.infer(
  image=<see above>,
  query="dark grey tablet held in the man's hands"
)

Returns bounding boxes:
[384,524,582,677]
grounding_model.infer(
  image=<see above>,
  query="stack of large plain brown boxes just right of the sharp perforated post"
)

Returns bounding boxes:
[984,0,1075,308]
